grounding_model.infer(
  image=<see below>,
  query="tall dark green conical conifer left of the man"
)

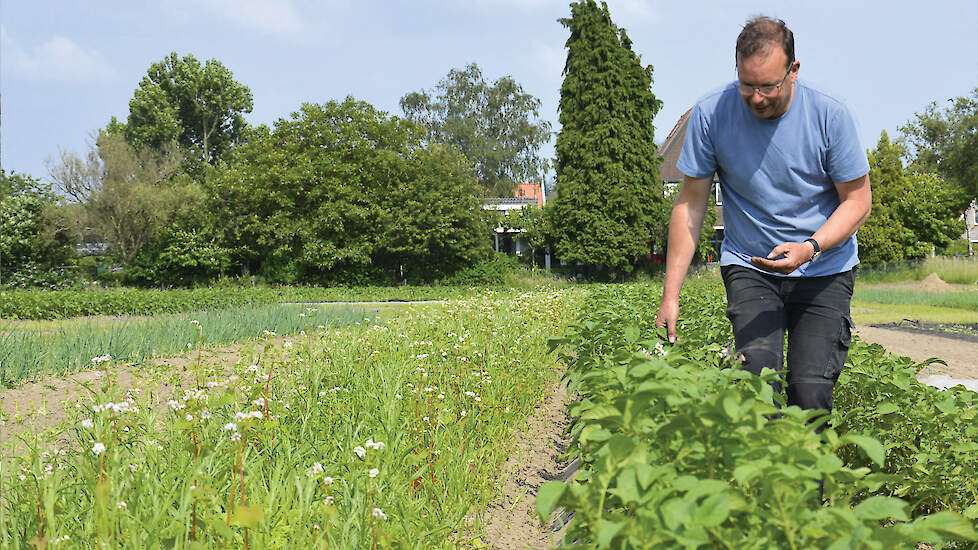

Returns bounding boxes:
[549,0,663,277]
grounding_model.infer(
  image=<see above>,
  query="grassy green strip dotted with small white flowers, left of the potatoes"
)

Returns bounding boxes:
[0,289,582,549]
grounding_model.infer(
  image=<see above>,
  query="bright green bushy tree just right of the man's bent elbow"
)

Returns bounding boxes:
[859,131,968,265]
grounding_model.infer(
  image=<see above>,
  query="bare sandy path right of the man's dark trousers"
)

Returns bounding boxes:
[856,326,978,378]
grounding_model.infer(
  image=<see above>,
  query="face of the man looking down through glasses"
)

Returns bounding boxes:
[737,46,799,119]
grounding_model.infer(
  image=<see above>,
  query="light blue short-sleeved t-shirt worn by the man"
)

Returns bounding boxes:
[677,81,869,277]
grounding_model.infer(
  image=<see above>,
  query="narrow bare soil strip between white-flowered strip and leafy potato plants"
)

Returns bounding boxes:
[483,383,570,550]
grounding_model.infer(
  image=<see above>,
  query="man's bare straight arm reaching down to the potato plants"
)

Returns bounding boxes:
[655,176,713,342]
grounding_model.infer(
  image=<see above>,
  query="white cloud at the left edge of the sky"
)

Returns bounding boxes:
[0,26,114,82]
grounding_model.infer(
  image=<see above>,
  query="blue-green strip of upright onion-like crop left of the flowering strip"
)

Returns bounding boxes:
[0,304,365,387]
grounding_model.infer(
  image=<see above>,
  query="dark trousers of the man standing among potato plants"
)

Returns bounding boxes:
[720,265,855,410]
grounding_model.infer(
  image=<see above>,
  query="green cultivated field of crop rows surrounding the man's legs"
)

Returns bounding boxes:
[0,275,978,548]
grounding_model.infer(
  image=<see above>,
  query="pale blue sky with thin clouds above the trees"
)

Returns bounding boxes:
[0,0,978,183]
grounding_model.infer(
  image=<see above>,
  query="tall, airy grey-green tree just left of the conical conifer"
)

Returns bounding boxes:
[401,63,550,197]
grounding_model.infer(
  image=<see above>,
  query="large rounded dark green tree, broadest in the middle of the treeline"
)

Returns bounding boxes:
[212,98,489,283]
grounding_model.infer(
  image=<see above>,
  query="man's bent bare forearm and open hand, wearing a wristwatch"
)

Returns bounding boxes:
[751,174,873,275]
